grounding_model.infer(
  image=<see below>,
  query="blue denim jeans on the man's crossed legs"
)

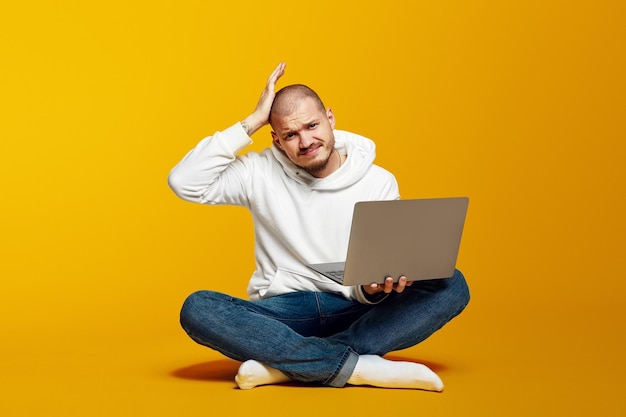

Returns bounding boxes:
[181,271,469,387]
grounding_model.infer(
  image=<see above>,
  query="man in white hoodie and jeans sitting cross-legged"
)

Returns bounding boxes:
[169,63,469,391]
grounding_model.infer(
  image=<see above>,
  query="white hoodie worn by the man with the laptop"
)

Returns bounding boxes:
[169,123,399,303]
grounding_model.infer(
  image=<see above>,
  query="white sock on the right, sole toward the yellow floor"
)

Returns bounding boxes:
[348,355,443,391]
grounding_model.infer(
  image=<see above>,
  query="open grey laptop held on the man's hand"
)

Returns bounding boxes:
[308,197,469,286]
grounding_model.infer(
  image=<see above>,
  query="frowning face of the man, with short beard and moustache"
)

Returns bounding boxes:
[272,98,337,178]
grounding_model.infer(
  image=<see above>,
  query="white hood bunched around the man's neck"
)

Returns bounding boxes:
[271,130,376,191]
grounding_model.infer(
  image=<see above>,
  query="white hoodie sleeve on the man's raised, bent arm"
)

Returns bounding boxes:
[168,123,252,204]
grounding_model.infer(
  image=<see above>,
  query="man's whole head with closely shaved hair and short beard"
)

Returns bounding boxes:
[269,84,340,178]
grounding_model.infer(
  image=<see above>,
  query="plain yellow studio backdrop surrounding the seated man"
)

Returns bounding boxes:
[0,0,626,416]
